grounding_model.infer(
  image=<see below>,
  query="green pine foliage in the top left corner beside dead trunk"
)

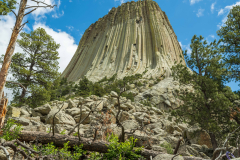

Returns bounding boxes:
[0,0,17,16]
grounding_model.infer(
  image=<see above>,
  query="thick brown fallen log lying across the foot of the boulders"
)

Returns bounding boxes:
[18,131,161,159]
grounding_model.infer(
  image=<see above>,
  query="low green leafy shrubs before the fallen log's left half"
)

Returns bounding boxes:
[33,141,86,160]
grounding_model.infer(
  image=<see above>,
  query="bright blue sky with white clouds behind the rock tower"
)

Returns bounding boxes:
[0,0,240,100]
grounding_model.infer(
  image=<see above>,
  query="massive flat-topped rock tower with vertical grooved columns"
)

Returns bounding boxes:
[62,0,185,81]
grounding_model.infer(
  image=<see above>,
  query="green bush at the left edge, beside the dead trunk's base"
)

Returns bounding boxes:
[1,119,22,141]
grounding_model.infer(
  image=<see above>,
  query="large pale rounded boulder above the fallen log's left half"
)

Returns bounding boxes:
[46,109,76,125]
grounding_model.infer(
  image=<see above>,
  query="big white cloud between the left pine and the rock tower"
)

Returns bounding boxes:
[33,23,77,72]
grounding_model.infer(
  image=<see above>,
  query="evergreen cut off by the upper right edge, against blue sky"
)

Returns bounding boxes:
[217,6,240,81]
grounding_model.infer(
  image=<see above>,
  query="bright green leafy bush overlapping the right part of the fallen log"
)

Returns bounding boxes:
[103,134,143,160]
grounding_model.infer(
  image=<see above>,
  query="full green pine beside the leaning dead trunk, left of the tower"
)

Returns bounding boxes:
[3,28,60,105]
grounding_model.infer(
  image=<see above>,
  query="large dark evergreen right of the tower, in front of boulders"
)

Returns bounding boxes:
[172,35,238,149]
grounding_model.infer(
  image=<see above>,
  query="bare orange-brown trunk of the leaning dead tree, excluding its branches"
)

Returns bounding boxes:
[0,0,27,102]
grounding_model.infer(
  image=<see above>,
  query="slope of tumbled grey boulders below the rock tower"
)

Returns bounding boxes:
[2,78,232,160]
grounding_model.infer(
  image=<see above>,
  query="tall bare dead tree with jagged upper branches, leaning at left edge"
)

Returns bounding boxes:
[0,0,56,102]
